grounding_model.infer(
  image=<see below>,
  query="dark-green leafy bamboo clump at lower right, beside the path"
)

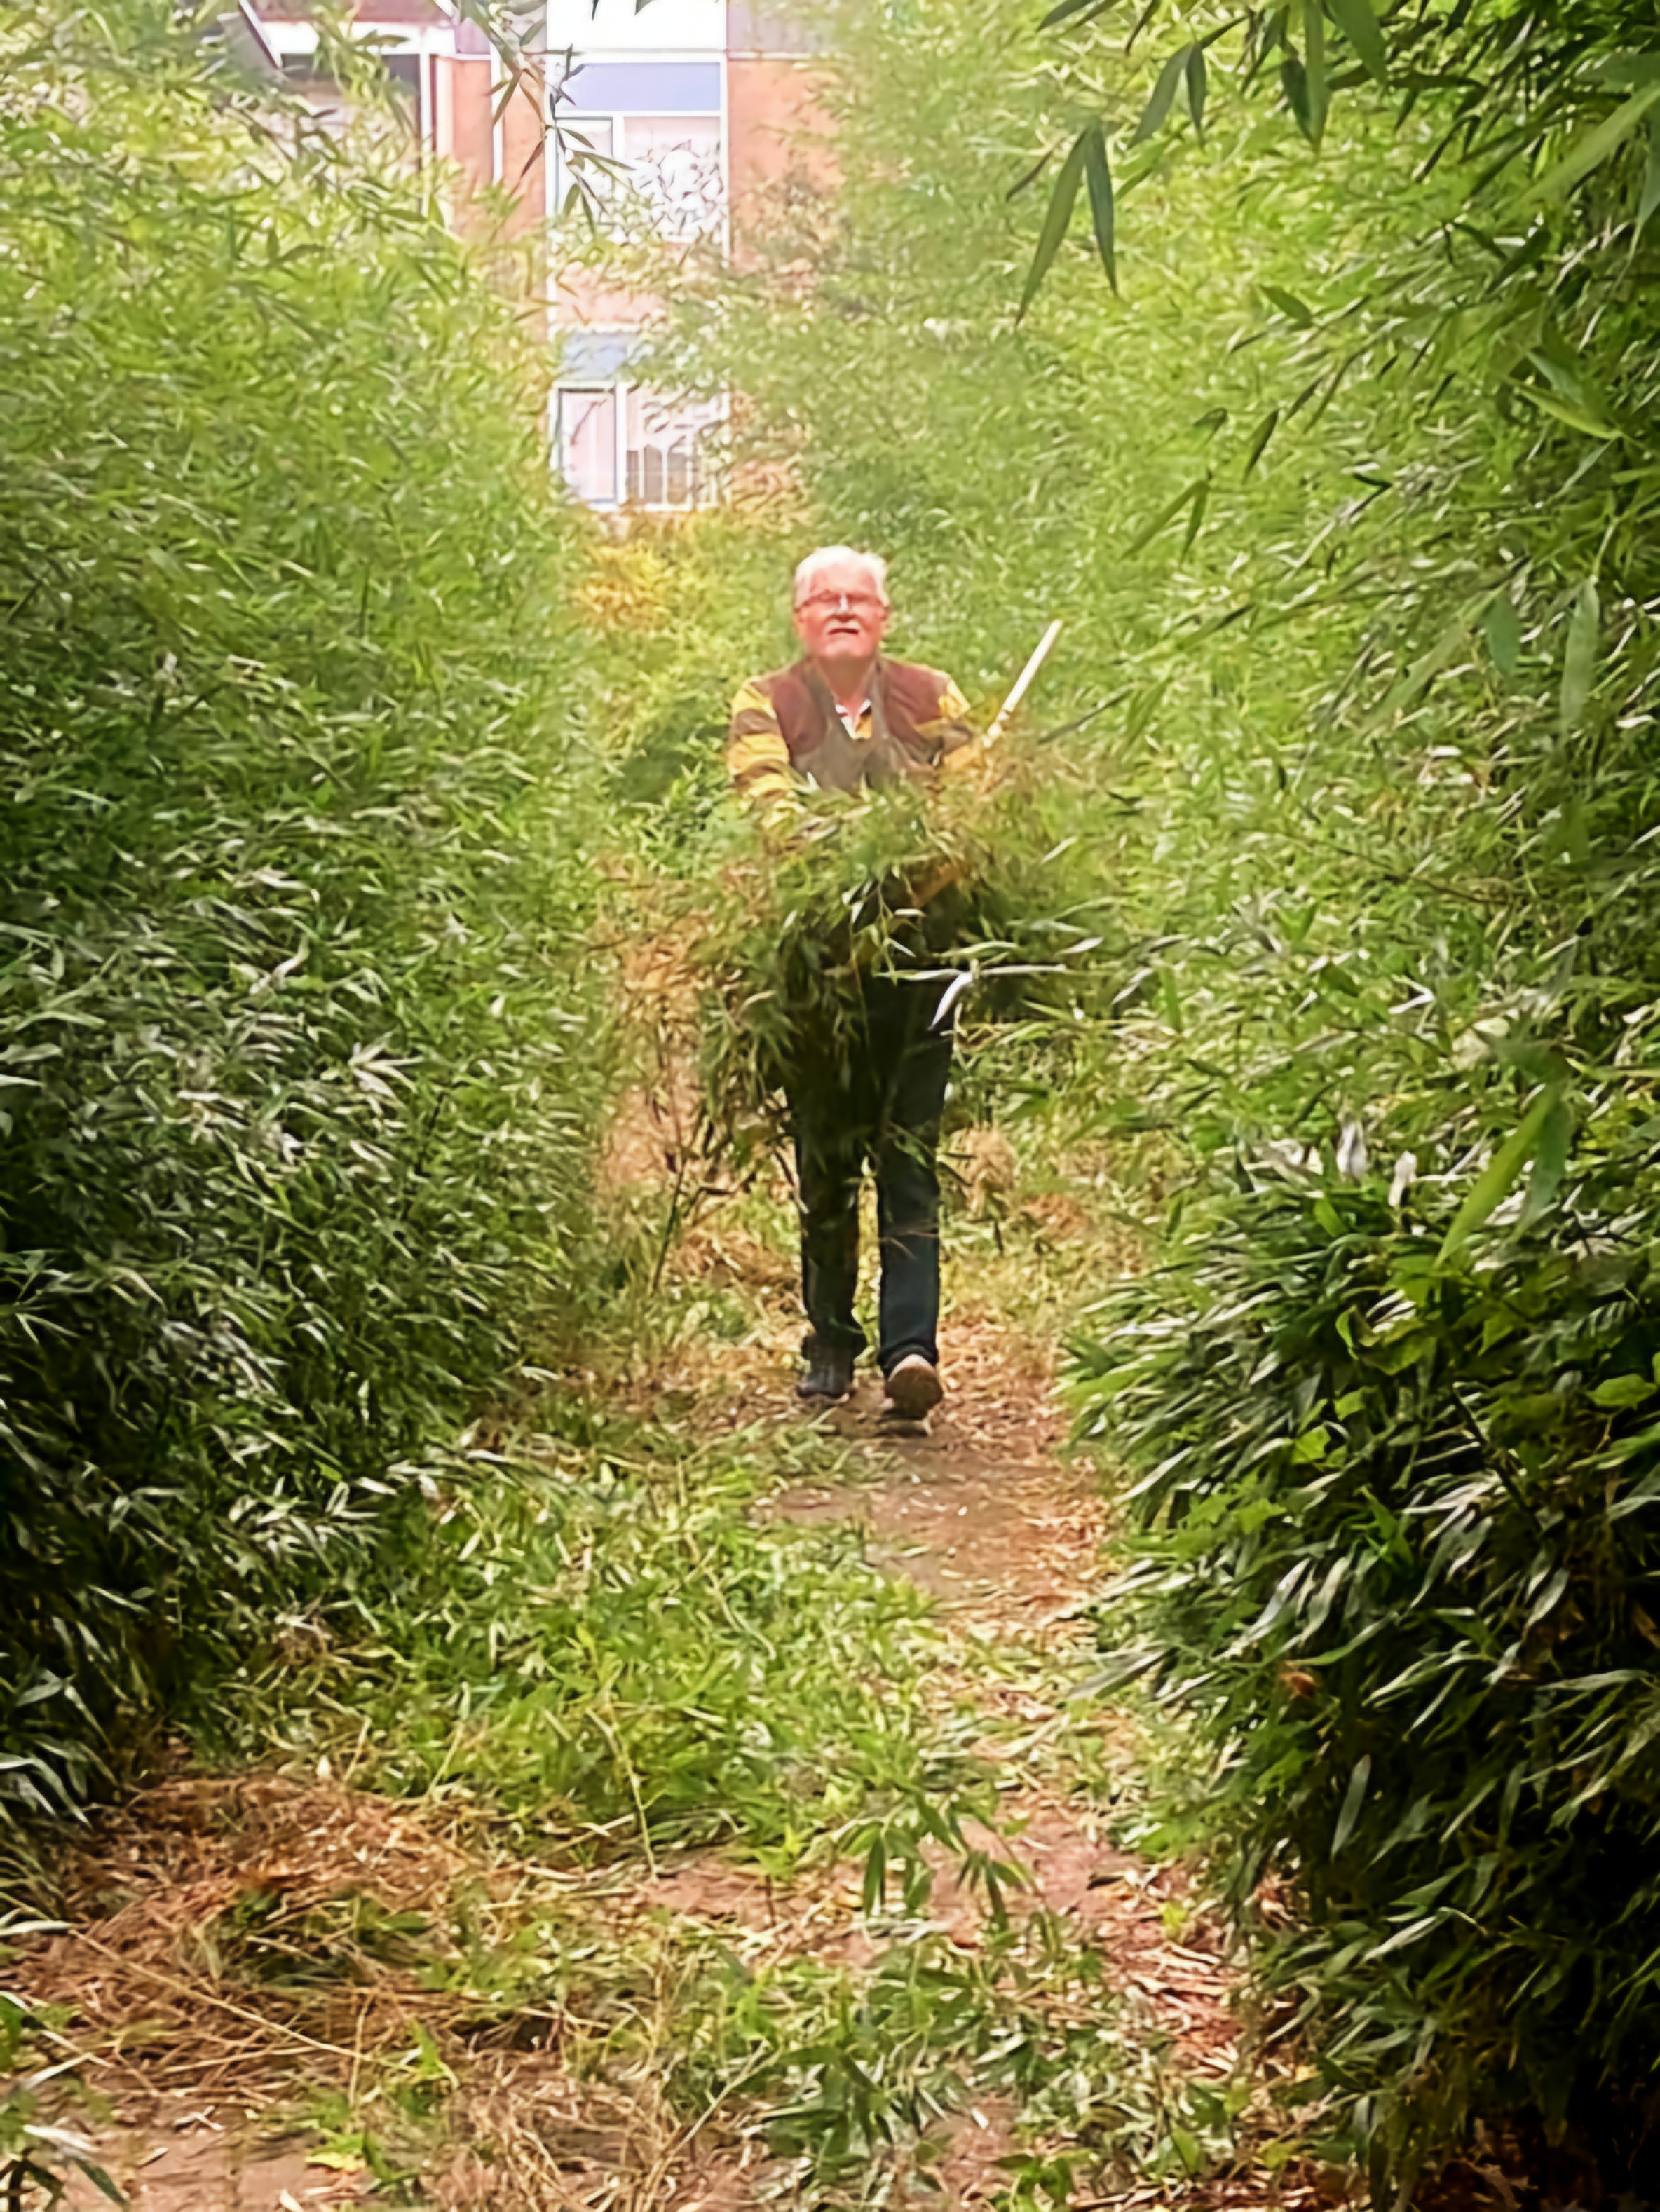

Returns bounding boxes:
[1075,1168,1660,2199]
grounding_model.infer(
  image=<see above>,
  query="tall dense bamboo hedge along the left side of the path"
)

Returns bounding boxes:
[0,0,591,1816]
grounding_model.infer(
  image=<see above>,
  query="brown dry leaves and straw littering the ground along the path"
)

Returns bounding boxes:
[0,1039,1345,2212]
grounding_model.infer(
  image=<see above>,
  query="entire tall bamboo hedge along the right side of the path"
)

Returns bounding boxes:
[651,0,1660,2185]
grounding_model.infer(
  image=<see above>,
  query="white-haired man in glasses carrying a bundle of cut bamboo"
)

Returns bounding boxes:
[726,547,981,1422]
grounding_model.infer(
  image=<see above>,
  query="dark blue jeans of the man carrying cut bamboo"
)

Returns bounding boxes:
[788,978,952,1374]
